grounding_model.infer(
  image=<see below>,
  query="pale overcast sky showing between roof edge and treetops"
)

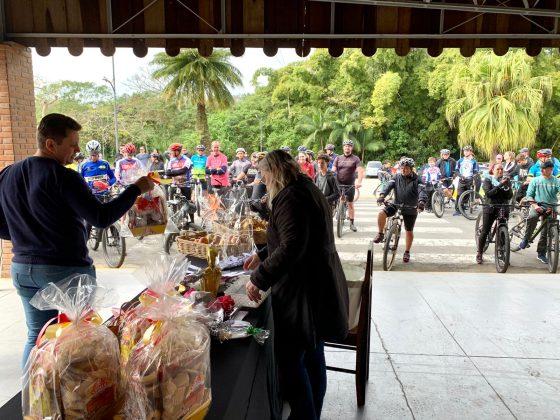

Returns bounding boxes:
[33,48,308,94]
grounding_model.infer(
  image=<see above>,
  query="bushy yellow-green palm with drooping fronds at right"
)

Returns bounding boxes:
[446,51,552,157]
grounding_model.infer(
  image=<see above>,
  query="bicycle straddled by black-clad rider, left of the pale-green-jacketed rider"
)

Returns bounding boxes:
[474,204,513,273]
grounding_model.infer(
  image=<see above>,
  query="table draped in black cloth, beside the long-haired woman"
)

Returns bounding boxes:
[0,262,282,420]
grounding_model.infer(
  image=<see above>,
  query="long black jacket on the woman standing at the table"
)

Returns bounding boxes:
[251,175,348,348]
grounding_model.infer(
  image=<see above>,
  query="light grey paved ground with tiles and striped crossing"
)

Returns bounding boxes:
[0,176,560,420]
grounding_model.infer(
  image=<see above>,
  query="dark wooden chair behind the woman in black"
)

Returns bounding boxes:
[325,242,373,407]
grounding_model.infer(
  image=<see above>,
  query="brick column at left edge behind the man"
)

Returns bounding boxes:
[0,42,37,277]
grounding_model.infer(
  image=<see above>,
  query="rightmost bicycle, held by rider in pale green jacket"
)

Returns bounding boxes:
[510,203,560,273]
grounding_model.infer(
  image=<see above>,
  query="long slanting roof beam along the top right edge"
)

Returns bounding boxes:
[309,0,560,18]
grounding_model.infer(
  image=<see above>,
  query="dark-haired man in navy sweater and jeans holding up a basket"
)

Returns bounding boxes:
[0,114,154,365]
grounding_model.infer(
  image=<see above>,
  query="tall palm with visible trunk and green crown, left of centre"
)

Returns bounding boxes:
[151,49,243,147]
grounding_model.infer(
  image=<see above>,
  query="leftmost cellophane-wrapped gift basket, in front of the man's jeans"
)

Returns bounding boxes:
[22,275,123,420]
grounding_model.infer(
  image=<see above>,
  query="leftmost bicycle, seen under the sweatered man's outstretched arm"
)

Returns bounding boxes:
[87,195,126,268]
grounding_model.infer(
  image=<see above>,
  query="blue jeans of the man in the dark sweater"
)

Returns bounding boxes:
[12,263,95,368]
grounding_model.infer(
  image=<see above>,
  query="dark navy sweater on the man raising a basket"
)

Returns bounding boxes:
[0,156,140,266]
